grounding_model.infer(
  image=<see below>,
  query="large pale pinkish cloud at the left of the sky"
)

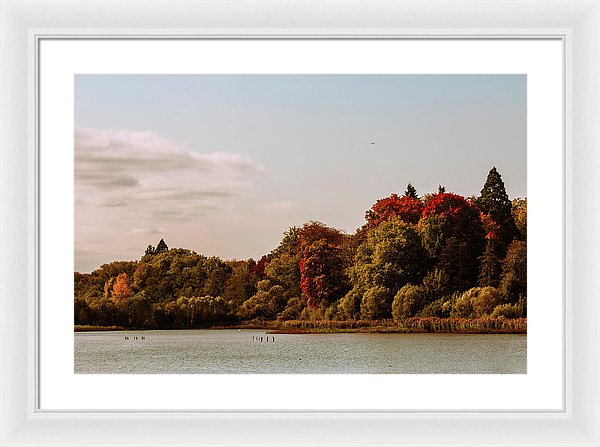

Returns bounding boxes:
[75,126,264,217]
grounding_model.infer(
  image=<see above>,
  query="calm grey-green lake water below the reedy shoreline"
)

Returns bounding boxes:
[75,329,527,374]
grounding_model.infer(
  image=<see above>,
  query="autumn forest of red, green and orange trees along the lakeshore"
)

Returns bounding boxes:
[74,167,527,332]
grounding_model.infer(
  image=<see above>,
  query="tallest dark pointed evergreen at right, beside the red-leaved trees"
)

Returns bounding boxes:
[476,166,517,257]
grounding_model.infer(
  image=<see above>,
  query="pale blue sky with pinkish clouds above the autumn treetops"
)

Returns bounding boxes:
[75,75,527,272]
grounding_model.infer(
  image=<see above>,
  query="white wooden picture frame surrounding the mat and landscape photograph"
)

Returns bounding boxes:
[0,0,600,446]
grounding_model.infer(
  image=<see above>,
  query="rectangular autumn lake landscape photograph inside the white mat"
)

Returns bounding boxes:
[73,73,524,374]
